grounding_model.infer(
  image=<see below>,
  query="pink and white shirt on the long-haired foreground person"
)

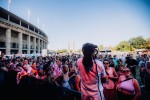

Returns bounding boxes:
[77,58,106,96]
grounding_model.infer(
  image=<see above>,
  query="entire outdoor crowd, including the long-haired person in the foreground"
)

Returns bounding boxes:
[0,43,150,100]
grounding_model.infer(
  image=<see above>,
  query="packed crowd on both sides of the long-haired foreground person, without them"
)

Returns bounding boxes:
[0,54,150,100]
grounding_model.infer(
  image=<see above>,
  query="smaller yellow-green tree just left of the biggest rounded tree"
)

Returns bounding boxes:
[116,41,130,51]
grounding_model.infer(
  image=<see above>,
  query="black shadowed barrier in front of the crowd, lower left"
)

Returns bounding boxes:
[0,71,81,100]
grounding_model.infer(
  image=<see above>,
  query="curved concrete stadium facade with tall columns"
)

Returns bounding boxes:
[0,7,48,55]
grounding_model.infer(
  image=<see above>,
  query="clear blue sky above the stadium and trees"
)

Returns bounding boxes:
[0,0,150,50]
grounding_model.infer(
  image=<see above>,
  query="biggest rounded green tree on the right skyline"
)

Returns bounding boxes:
[128,36,146,49]
